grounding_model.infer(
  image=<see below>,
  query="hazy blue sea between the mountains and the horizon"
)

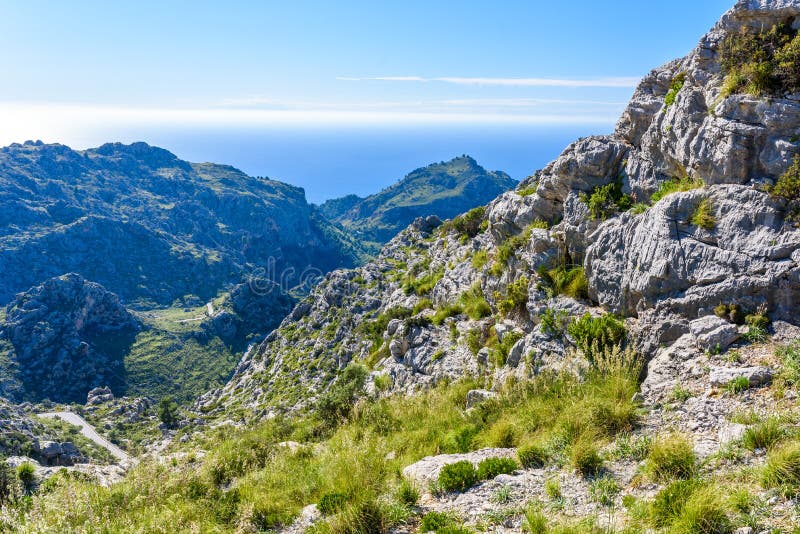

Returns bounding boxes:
[115,124,613,203]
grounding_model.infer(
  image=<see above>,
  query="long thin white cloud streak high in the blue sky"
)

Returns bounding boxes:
[337,76,640,88]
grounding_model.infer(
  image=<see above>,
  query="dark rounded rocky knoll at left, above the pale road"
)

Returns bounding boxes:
[2,274,140,402]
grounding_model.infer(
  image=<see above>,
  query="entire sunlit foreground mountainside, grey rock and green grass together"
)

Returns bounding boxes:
[7,0,800,533]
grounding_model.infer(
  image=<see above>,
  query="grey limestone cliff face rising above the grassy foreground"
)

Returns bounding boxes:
[206,1,800,415]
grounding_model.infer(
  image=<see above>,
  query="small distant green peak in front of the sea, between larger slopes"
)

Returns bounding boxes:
[320,156,516,253]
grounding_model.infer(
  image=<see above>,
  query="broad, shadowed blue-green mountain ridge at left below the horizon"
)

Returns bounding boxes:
[0,142,360,307]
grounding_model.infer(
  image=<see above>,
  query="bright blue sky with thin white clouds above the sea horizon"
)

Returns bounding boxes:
[0,0,732,141]
